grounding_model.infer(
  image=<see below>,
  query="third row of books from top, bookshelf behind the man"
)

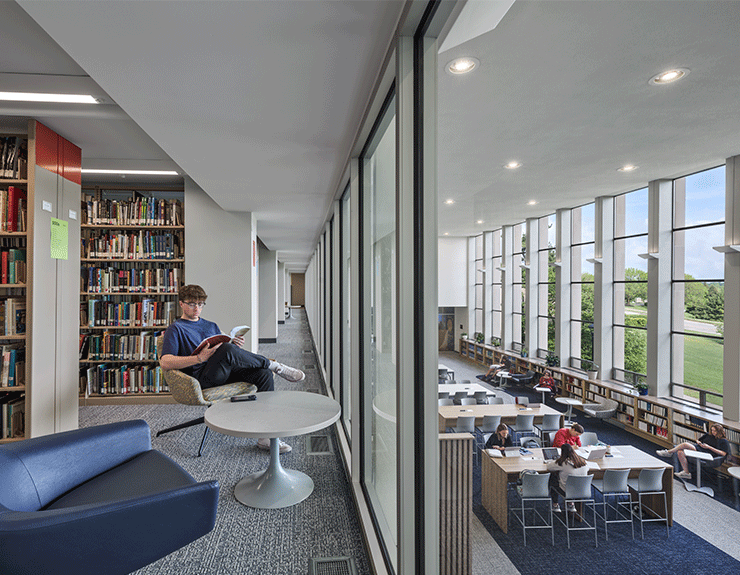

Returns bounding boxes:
[80,266,182,294]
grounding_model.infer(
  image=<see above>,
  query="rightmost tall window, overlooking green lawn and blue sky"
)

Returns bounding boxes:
[671,166,725,405]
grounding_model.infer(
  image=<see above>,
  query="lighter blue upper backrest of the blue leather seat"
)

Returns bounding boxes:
[0,419,151,511]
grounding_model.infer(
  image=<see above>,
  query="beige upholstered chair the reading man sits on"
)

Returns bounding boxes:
[157,335,257,457]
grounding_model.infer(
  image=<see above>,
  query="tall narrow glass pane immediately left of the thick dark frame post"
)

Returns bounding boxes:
[361,98,398,561]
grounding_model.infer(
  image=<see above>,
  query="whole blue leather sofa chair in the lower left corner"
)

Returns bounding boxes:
[0,420,218,575]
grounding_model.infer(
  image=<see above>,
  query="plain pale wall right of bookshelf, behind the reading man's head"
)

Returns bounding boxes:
[185,178,259,351]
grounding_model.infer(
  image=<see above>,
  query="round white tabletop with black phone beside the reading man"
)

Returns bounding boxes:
[205,391,341,438]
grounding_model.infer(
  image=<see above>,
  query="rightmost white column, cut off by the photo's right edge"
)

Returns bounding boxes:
[722,156,740,421]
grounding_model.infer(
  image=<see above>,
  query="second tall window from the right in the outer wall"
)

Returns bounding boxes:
[614,188,648,384]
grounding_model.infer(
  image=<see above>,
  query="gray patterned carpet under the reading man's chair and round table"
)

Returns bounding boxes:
[80,310,371,575]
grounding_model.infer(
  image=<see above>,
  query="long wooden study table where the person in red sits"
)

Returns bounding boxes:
[481,445,673,533]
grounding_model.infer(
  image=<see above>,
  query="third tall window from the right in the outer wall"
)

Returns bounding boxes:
[570,203,595,367]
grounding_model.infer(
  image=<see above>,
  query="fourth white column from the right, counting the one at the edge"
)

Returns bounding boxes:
[555,209,571,367]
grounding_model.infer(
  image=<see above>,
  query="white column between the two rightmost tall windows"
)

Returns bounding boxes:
[645,180,673,397]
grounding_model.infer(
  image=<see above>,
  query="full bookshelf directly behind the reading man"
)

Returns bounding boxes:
[79,186,185,405]
